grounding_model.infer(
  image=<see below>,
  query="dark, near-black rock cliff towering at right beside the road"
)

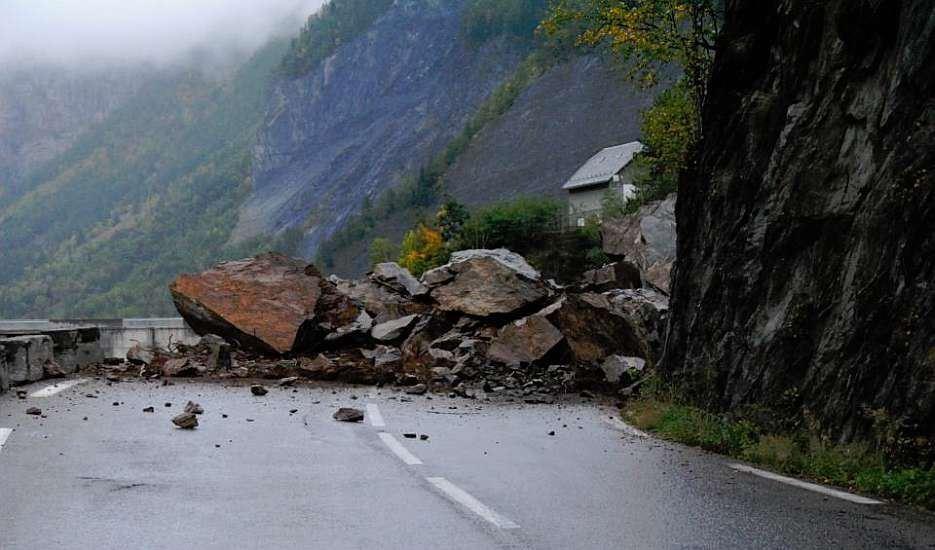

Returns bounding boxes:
[665,0,935,440]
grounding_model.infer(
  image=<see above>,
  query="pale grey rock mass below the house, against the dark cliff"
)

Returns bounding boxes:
[601,195,676,294]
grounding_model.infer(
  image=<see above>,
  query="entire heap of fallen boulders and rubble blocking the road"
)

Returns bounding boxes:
[80,198,675,401]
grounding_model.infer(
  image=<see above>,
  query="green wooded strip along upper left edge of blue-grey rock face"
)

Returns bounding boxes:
[280,0,393,78]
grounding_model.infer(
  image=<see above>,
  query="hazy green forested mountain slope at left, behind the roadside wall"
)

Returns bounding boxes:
[0,40,291,317]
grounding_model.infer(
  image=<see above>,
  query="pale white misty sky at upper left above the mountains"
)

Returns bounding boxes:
[0,0,325,67]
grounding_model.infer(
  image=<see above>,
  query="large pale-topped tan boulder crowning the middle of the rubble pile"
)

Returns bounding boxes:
[423,249,551,317]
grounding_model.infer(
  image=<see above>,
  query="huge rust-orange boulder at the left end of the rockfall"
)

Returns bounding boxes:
[169,253,350,354]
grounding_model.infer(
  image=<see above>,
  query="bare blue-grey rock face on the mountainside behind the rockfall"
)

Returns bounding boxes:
[234,0,521,254]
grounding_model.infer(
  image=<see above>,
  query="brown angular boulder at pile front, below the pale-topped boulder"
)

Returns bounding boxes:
[487,315,564,366]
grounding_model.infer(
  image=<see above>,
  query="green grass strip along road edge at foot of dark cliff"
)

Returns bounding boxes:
[624,398,935,510]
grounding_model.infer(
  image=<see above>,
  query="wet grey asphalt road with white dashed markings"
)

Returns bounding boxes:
[0,380,935,550]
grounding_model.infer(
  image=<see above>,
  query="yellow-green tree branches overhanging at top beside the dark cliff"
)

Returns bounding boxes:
[543,0,723,130]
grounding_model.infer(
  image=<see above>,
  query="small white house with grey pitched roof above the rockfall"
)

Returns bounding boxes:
[562,141,643,226]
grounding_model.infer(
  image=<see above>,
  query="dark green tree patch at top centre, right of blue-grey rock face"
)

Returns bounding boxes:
[461,0,548,46]
